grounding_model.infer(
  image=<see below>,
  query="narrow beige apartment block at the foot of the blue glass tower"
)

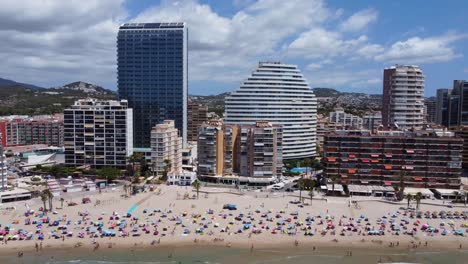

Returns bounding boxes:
[151,120,182,176]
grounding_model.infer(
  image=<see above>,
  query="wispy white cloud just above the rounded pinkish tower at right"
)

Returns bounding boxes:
[375,33,467,64]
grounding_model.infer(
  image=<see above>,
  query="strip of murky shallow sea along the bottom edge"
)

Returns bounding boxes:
[0,246,468,264]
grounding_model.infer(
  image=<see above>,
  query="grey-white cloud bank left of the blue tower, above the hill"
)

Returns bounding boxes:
[0,0,126,88]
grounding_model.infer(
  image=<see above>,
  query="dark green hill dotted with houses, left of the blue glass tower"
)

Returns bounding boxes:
[0,79,117,115]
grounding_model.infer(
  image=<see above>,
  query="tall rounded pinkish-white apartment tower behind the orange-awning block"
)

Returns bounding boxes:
[382,65,425,130]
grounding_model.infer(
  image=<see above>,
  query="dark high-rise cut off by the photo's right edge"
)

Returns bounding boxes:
[448,80,468,128]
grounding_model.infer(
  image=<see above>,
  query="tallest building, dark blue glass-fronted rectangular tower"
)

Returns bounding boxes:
[117,23,188,147]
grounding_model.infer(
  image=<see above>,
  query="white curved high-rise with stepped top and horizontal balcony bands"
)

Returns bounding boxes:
[224,62,317,160]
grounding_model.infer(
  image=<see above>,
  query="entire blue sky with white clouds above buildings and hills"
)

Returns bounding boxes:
[0,0,468,96]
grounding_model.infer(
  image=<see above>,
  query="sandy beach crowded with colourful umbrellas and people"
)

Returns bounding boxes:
[0,186,468,263]
